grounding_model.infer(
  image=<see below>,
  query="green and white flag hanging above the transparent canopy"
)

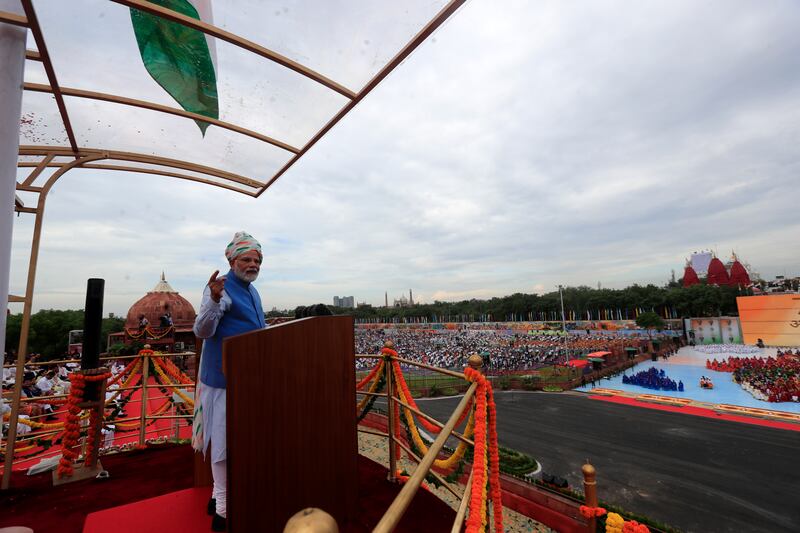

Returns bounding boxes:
[131,0,219,136]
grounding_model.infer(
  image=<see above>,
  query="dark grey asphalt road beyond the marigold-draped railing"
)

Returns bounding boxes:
[417,392,800,533]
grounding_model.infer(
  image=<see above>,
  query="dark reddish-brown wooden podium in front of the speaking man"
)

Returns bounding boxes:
[222,316,358,533]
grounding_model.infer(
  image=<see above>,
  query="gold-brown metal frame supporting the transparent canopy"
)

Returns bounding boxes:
[0,0,466,489]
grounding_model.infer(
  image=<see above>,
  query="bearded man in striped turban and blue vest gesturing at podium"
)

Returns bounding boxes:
[192,231,266,531]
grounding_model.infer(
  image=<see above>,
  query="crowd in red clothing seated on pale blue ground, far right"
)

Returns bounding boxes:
[706,356,800,402]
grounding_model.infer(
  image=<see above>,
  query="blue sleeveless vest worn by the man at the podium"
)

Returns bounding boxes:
[200,270,266,389]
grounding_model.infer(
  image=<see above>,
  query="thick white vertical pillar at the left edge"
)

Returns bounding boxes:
[0,0,28,372]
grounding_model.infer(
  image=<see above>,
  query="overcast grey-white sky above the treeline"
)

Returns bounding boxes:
[11,0,800,313]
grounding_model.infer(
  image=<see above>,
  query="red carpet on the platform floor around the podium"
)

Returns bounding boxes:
[0,445,455,533]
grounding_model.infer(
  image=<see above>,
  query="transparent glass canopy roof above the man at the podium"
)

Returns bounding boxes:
[12,0,464,196]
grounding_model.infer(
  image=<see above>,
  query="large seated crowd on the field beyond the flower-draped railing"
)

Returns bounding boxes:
[355,328,646,371]
